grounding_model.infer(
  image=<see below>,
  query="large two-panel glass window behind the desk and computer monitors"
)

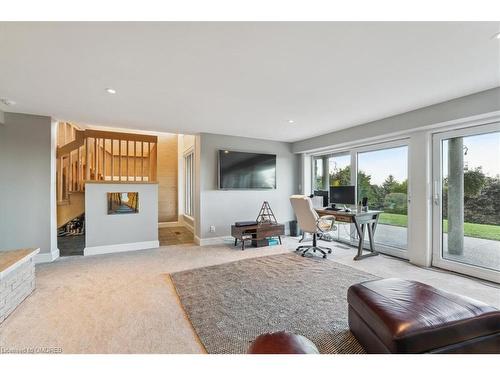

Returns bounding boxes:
[313,141,408,258]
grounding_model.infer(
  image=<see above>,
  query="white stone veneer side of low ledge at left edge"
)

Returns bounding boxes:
[0,256,35,323]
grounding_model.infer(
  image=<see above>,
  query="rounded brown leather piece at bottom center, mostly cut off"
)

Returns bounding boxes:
[248,331,319,354]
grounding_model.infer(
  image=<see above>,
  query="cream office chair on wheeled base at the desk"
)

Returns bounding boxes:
[290,195,335,258]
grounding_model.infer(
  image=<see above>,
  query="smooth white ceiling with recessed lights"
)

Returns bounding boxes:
[0,22,500,141]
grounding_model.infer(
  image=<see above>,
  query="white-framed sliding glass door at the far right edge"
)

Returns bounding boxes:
[433,123,500,282]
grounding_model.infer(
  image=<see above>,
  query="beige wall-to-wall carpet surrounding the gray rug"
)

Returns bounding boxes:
[0,238,500,353]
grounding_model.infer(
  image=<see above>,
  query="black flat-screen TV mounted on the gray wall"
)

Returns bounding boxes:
[219,150,276,189]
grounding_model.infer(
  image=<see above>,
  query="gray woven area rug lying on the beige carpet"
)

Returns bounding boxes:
[171,253,377,354]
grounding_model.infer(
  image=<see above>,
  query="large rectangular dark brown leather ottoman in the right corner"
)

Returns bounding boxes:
[347,279,500,353]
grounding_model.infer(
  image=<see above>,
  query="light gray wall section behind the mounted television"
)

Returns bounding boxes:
[195,133,300,240]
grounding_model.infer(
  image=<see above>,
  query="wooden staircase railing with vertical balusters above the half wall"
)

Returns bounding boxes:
[56,122,158,204]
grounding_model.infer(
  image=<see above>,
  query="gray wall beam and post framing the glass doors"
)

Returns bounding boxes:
[292,88,500,266]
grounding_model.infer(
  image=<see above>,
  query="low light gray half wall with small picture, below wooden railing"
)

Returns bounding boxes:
[84,183,159,255]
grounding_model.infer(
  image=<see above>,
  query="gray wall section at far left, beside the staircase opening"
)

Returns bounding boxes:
[0,112,58,261]
